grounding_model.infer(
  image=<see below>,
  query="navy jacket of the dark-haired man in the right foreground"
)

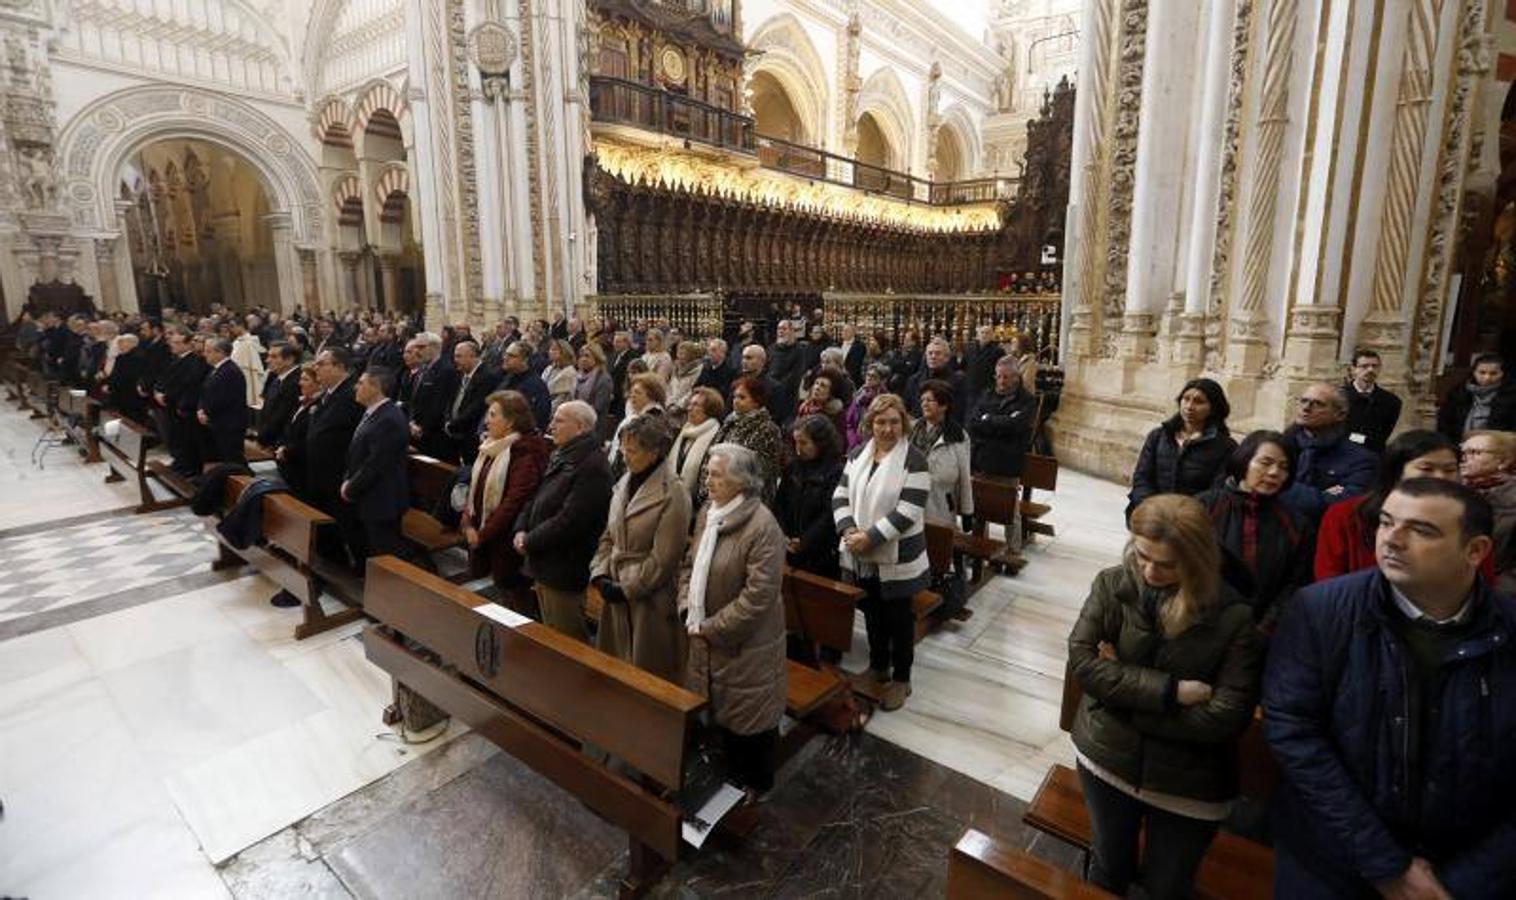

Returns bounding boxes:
[1263,568,1516,897]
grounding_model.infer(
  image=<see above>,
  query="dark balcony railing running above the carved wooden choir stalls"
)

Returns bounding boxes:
[590,76,1017,206]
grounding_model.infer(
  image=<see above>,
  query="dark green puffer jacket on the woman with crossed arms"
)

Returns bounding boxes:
[1069,565,1263,803]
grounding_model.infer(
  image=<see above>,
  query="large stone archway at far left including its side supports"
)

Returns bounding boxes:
[58,85,323,312]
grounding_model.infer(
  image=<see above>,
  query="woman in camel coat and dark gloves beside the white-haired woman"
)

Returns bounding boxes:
[590,415,690,683]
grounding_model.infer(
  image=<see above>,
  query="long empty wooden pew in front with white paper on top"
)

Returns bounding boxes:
[364,556,705,895]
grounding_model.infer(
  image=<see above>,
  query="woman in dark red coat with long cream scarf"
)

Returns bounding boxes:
[459,391,547,615]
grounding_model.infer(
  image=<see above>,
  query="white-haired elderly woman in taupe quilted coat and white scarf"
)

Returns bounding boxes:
[679,444,785,792]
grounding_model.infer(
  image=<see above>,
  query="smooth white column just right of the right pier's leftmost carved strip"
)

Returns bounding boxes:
[1122,3,1201,356]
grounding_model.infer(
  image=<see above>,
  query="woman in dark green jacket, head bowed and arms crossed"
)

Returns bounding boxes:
[1069,494,1263,900]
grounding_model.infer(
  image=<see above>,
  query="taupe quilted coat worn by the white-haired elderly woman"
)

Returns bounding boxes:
[679,497,785,735]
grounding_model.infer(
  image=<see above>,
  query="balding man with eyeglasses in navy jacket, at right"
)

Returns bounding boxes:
[1284,382,1380,518]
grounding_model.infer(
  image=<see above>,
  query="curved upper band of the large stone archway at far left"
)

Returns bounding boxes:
[58,85,323,245]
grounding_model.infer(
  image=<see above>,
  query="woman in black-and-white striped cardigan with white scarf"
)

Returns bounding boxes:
[832,394,931,711]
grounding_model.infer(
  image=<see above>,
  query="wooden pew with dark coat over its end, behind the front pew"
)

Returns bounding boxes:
[212,476,364,639]
